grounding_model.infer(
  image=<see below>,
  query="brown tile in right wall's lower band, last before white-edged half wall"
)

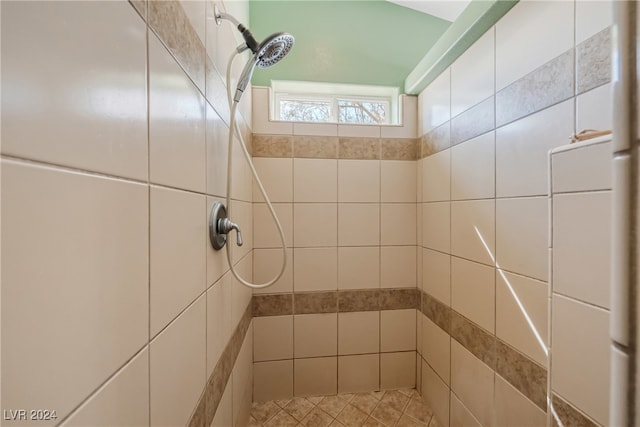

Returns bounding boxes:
[495,339,547,412]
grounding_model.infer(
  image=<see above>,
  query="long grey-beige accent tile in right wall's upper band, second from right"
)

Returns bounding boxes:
[496,49,574,127]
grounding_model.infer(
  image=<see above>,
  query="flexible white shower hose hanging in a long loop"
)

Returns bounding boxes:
[226,50,287,289]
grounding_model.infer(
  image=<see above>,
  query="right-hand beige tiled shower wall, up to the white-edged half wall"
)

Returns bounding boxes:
[418,1,612,426]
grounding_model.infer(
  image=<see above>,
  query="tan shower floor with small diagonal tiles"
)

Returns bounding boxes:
[249,389,440,427]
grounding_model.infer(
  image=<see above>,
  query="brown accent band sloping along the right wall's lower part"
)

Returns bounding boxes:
[420,292,552,412]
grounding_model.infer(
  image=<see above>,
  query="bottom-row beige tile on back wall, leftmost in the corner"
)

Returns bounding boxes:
[253,360,293,402]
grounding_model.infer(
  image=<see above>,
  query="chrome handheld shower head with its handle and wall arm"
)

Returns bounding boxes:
[214,6,295,102]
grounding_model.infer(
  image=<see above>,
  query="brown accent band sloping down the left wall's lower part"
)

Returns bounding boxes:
[188,303,252,427]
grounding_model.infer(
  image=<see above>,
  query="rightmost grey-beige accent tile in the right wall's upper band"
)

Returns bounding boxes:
[576,27,612,94]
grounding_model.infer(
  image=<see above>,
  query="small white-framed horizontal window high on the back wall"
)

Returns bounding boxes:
[271,81,398,125]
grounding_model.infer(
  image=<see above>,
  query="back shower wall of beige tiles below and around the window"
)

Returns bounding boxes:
[248,87,417,401]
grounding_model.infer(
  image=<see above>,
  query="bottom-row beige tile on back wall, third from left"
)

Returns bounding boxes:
[338,354,380,393]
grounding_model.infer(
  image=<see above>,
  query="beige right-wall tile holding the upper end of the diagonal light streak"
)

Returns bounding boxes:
[450,200,495,265]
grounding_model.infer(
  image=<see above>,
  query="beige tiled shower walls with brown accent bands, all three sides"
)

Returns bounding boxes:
[0,0,636,427]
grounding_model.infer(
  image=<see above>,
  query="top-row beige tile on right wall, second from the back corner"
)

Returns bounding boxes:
[451,27,495,117]
